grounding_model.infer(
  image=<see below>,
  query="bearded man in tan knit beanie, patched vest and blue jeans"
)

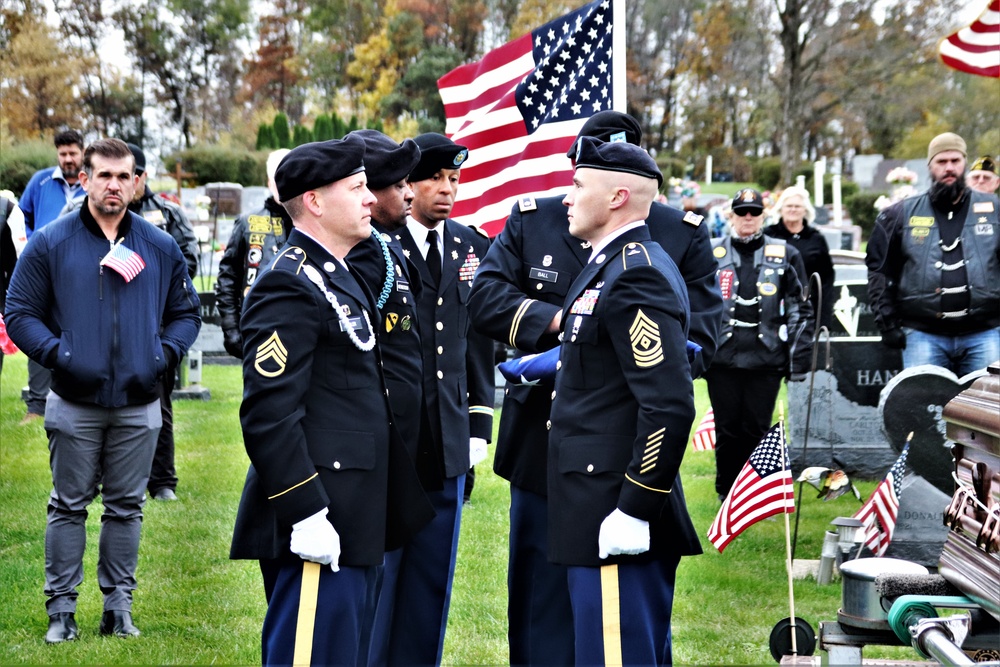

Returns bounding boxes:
[865,132,1000,377]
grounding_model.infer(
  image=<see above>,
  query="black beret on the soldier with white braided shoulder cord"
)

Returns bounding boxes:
[274,134,365,201]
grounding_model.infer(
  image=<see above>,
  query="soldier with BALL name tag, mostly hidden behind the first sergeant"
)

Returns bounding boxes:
[469,111,722,665]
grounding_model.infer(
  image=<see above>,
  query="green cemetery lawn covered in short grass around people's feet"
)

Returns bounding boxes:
[0,354,914,665]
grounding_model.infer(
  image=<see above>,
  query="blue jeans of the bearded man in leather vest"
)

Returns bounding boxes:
[903,327,1000,377]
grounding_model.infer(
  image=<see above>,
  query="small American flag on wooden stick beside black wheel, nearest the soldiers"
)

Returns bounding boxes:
[708,422,795,553]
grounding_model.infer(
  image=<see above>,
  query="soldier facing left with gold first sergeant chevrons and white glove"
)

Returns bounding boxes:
[548,137,701,665]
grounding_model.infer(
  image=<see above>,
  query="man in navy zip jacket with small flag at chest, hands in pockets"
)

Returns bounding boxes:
[6,139,201,643]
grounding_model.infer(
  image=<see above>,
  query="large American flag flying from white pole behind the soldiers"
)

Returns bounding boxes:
[438,0,625,236]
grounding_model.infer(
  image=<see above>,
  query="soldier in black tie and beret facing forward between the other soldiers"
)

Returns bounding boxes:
[370,133,494,664]
